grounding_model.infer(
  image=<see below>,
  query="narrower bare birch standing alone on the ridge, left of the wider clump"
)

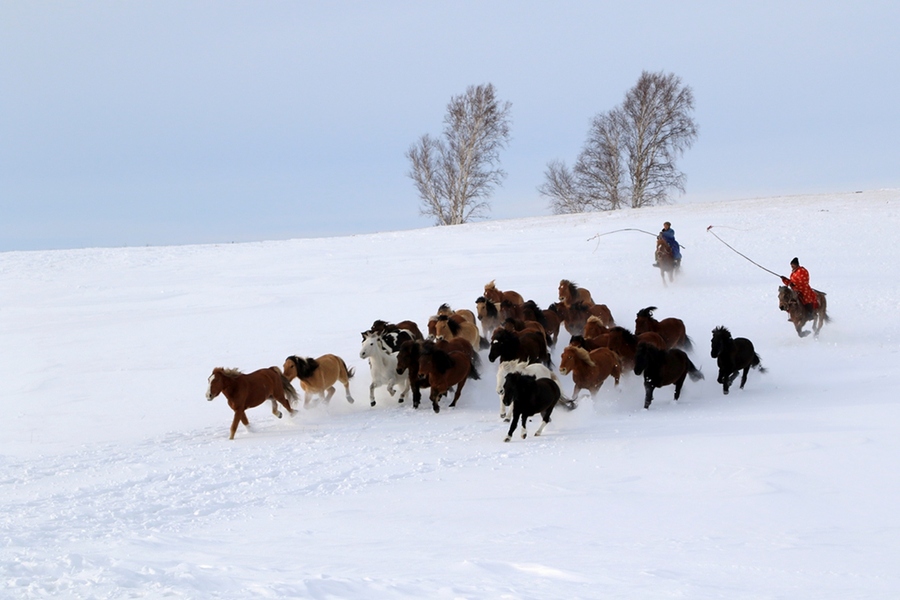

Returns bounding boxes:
[406,84,512,225]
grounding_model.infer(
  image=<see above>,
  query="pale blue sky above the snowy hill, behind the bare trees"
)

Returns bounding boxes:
[0,0,900,251]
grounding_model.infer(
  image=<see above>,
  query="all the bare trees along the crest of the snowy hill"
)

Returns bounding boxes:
[406,71,697,225]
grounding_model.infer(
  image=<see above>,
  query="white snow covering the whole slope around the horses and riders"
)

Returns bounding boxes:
[0,190,900,599]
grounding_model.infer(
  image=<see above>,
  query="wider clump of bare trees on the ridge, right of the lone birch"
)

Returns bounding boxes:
[538,71,697,214]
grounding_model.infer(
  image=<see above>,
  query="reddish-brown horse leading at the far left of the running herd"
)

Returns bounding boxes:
[206,367,297,440]
